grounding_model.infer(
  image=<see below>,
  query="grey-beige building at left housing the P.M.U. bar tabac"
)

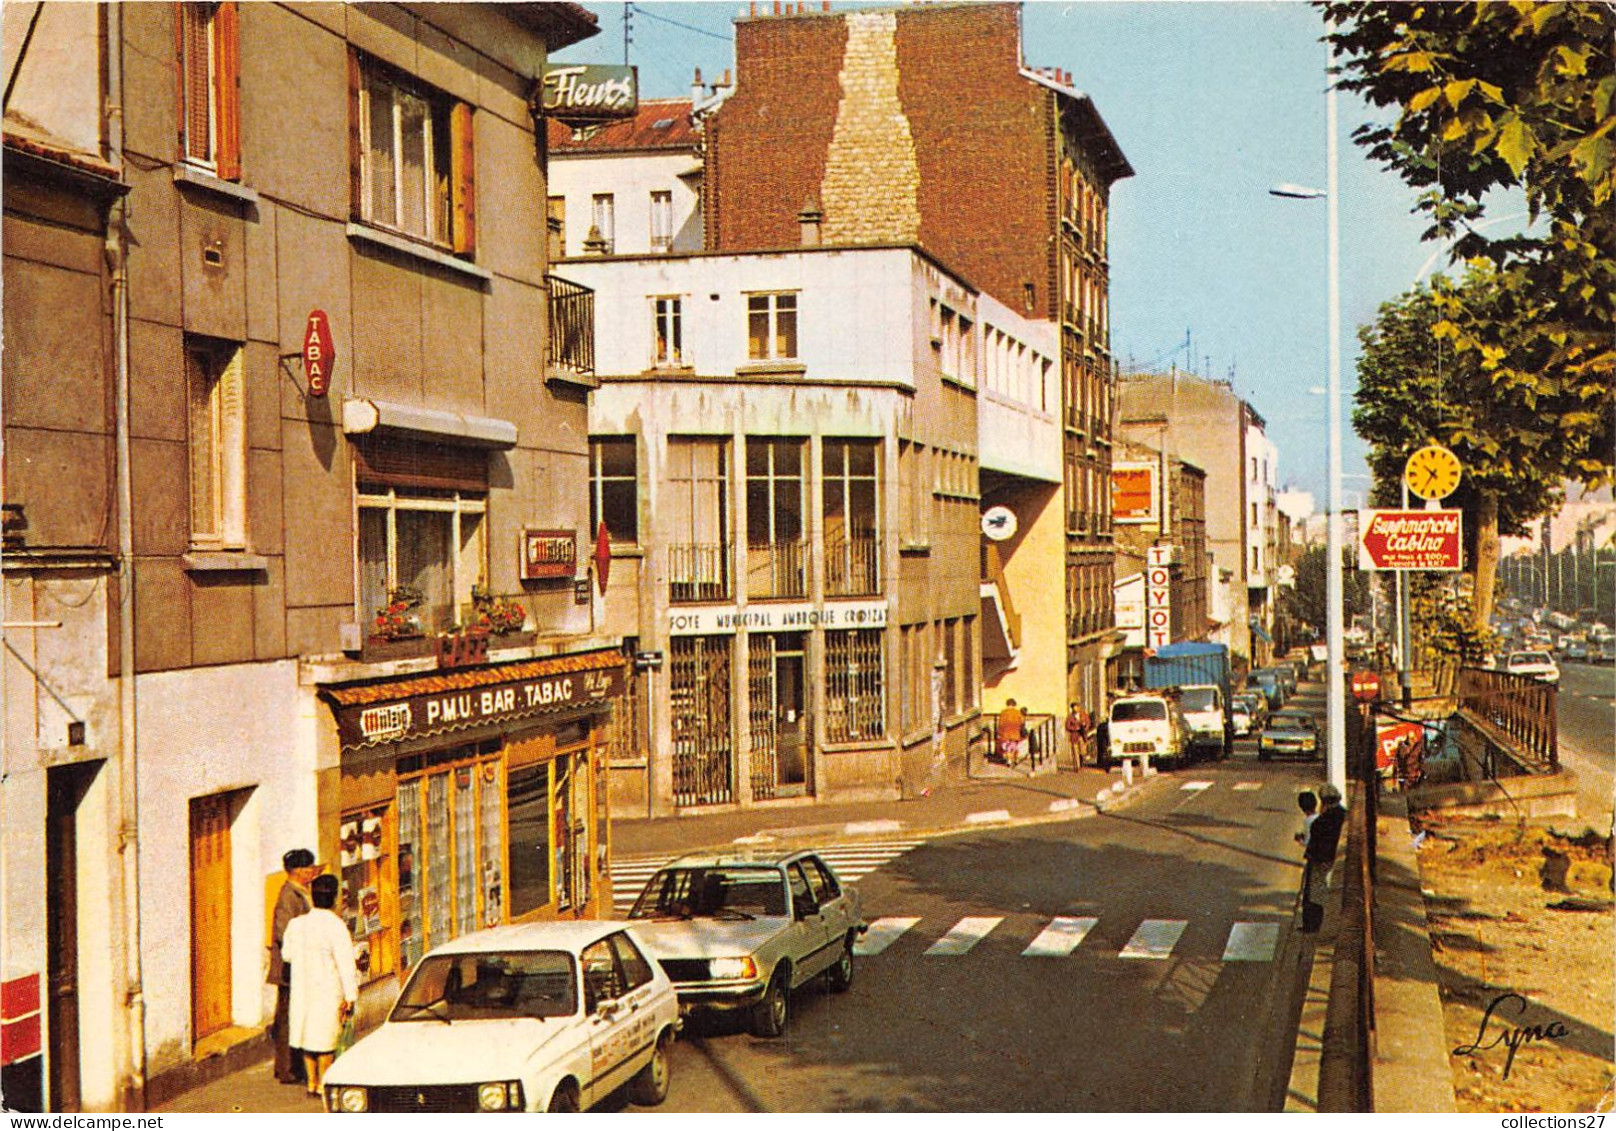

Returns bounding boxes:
[0,3,624,1110]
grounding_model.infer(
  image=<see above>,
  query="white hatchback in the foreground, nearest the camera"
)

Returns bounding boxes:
[325,921,679,1112]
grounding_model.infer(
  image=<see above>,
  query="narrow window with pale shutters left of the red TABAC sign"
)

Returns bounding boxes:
[186,336,247,549]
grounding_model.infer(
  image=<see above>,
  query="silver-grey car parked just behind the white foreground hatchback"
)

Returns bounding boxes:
[629,850,868,1037]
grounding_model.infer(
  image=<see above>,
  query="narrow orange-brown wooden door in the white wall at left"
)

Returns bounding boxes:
[191,793,231,1041]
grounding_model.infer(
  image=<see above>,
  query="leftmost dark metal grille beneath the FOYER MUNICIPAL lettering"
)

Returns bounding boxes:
[667,637,734,806]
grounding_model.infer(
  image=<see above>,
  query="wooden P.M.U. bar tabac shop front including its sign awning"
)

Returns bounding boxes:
[320,650,624,1005]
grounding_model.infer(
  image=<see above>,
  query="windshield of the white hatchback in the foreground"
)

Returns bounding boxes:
[388,950,579,1021]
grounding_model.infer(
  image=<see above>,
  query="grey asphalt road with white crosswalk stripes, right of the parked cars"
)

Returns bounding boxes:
[636,714,1322,1112]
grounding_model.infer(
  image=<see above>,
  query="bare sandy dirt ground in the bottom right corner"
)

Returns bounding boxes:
[1419,819,1616,1112]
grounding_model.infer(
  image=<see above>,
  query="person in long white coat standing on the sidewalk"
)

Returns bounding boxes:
[283,876,359,1095]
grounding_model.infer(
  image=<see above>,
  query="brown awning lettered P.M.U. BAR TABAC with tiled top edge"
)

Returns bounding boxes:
[320,650,625,751]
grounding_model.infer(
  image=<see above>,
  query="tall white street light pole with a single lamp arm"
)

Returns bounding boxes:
[1269,33,1346,790]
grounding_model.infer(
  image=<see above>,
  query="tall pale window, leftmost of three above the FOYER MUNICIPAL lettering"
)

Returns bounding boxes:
[666,438,730,601]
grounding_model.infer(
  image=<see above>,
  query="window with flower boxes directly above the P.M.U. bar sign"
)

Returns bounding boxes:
[359,483,488,633]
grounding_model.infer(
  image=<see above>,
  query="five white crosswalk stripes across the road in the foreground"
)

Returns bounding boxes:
[853,914,1283,963]
